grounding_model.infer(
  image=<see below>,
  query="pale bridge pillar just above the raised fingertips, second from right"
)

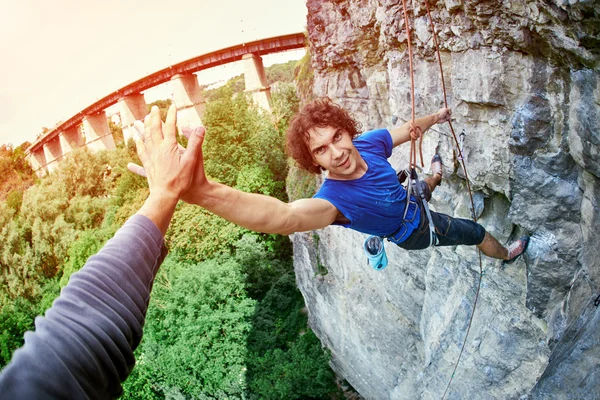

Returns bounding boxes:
[171,74,206,132]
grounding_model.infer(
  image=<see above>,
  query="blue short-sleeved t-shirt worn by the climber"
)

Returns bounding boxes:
[313,129,420,239]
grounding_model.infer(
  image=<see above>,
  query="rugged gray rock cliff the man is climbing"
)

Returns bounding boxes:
[293,0,600,399]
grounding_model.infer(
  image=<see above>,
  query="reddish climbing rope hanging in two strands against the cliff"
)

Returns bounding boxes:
[402,0,484,400]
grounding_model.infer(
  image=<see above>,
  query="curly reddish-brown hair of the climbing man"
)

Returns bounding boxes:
[285,97,361,174]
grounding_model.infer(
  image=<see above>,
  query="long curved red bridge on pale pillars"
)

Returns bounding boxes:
[27,33,306,176]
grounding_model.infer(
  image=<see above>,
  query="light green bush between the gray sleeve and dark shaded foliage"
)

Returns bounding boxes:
[125,257,256,398]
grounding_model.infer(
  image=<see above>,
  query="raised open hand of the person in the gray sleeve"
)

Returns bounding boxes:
[127,105,206,199]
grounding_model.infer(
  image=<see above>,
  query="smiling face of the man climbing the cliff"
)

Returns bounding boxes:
[308,126,367,180]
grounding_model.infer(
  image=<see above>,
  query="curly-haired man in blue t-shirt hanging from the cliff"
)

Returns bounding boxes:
[130,99,529,263]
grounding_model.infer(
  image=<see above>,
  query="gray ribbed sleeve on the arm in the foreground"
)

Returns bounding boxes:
[0,215,167,399]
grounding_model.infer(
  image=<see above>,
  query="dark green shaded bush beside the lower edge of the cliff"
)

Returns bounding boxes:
[248,273,337,399]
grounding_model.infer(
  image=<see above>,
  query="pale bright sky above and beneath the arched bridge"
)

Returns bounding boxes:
[0,0,307,146]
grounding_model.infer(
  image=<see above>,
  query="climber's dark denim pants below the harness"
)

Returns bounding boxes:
[397,203,485,250]
